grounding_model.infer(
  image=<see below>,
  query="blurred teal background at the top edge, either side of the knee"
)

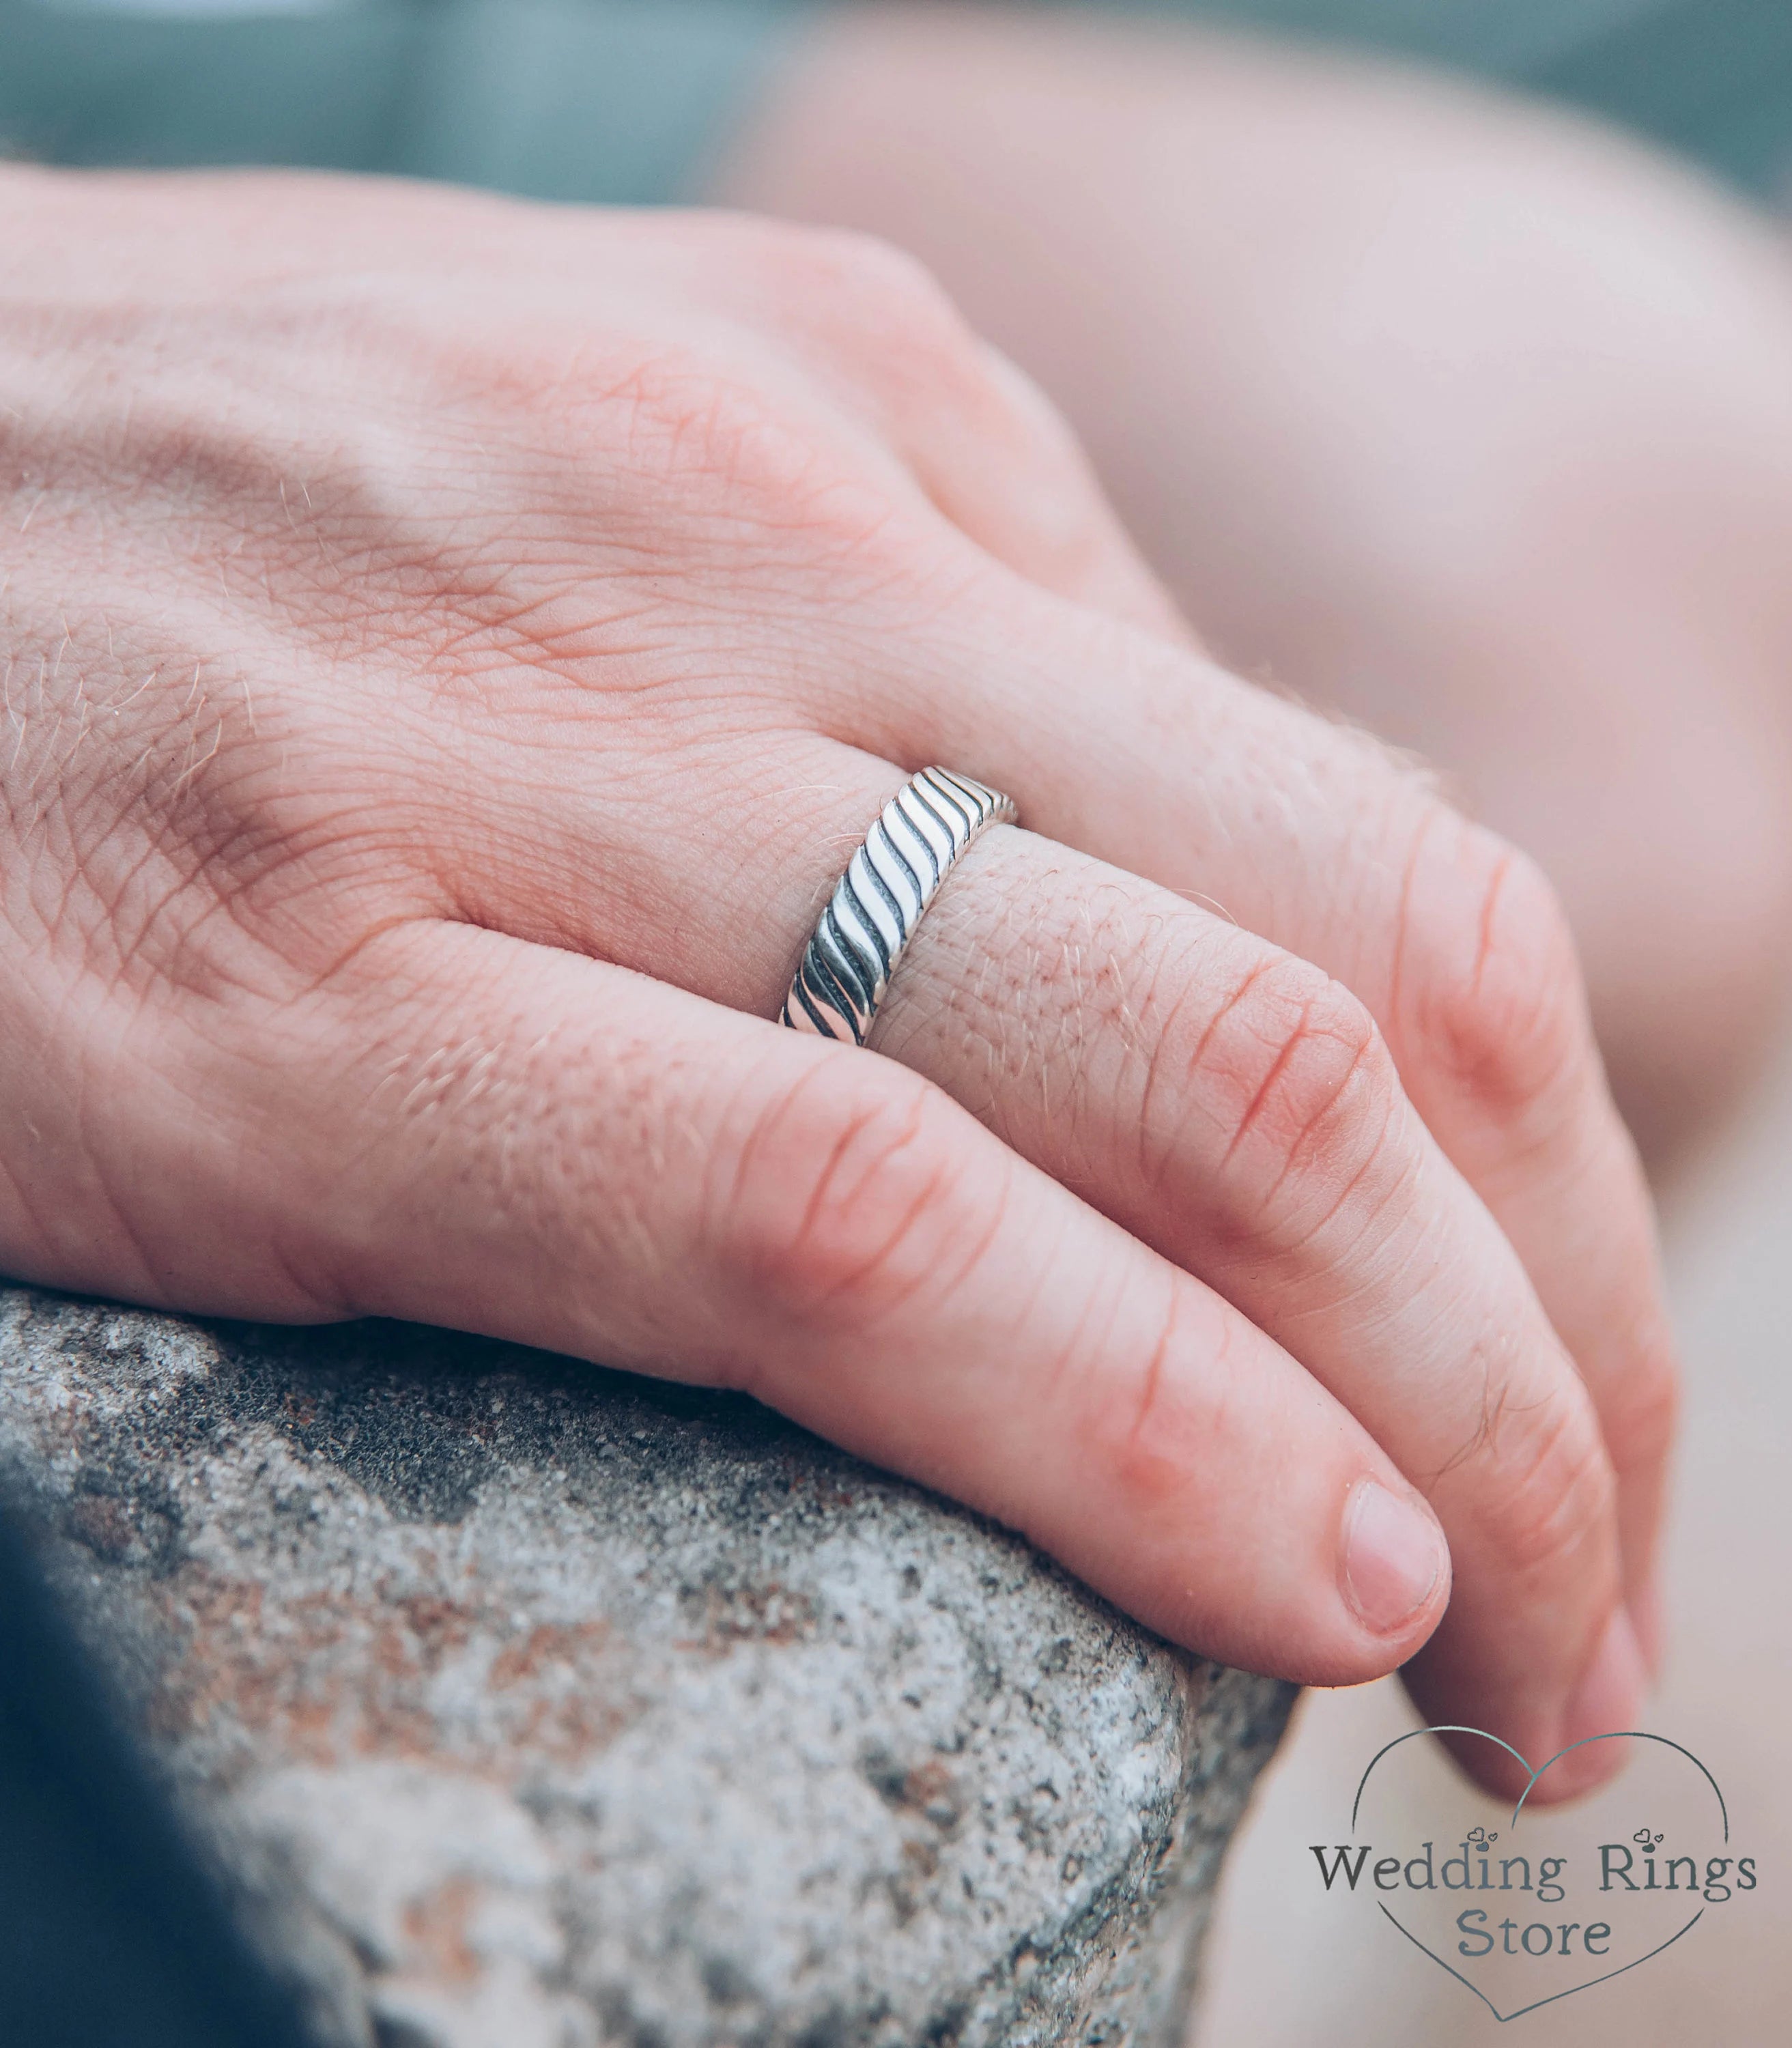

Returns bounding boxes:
[0,0,1792,203]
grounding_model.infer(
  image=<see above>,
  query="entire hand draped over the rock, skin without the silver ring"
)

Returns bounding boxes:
[0,170,1673,1790]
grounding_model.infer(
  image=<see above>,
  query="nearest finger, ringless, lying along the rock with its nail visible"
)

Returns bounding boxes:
[126,922,1448,1683]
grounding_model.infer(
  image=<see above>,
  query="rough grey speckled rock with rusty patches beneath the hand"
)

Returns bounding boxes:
[0,1288,1290,2048]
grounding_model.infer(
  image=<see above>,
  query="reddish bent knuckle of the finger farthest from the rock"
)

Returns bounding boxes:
[1401,827,1593,1124]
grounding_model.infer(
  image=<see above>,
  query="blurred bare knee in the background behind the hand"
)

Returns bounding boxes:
[713,6,1792,1174]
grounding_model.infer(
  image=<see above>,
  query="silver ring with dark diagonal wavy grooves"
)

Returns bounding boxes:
[780,768,1020,1044]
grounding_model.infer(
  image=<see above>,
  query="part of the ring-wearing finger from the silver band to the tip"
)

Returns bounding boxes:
[870,831,1640,1792]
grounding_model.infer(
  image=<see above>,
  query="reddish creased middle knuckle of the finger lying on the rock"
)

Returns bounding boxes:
[721,1061,987,1329]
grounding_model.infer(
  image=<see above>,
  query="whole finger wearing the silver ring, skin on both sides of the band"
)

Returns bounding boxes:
[389,713,1620,1767]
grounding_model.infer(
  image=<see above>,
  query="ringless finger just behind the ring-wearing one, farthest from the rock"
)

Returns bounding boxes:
[823,571,1675,1679]
